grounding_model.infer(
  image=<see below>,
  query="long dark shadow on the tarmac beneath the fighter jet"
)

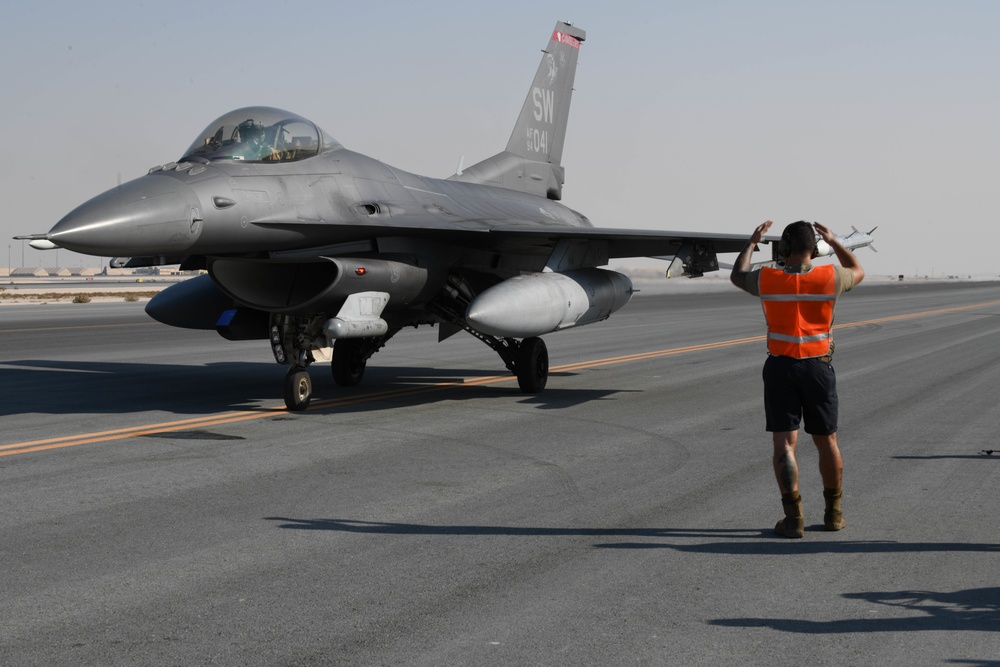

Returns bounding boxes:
[0,359,620,416]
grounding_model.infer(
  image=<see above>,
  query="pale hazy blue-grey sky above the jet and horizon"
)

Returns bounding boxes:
[0,0,1000,276]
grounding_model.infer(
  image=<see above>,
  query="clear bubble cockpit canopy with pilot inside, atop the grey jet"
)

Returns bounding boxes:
[181,107,340,162]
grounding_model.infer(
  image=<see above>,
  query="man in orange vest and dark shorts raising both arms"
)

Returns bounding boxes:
[730,220,865,538]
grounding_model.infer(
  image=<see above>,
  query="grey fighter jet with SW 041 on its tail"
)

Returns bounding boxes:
[16,22,870,410]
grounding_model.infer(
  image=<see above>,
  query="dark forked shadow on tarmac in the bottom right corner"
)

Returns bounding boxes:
[709,588,1000,640]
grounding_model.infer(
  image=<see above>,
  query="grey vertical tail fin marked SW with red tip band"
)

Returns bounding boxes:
[452,22,587,199]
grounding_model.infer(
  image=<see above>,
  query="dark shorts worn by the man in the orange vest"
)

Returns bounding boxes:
[763,356,838,435]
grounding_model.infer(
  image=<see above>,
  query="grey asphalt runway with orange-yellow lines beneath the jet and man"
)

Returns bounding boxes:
[0,283,1000,665]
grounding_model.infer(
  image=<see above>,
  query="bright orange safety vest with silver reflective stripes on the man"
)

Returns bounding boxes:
[759,264,837,359]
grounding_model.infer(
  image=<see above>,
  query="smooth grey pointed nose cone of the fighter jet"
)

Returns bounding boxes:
[48,174,202,257]
